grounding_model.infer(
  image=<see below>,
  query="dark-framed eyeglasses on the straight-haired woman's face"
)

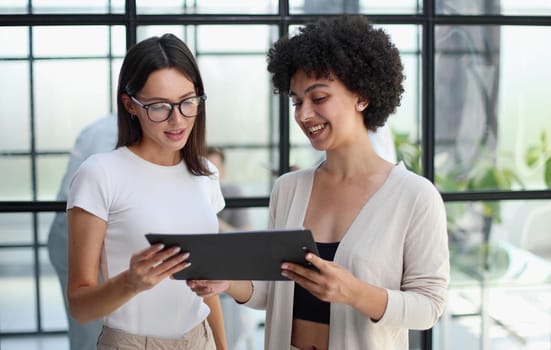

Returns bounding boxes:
[130,95,207,123]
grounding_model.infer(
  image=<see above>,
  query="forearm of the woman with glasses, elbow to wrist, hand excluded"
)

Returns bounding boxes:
[67,272,137,323]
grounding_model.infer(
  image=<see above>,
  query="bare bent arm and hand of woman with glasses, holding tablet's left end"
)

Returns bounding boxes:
[67,207,188,323]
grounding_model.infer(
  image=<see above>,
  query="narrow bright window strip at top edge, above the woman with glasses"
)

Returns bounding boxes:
[136,0,278,15]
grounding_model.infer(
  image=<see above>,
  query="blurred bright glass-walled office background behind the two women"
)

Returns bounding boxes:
[0,0,551,350]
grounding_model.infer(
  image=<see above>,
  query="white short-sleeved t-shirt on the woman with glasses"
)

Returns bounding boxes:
[67,147,224,338]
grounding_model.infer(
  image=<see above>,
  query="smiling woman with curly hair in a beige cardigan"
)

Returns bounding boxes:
[188,16,449,350]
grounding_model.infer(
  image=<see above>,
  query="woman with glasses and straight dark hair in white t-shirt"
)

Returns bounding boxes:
[67,34,226,350]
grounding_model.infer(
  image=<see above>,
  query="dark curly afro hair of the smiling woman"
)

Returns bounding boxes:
[268,15,404,131]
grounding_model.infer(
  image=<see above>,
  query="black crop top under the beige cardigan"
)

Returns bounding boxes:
[293,242,339,324]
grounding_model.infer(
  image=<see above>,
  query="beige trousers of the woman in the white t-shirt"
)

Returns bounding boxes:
[97,320,216,350]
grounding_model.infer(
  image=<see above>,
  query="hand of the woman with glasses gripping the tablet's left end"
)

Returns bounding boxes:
[127,244,190,293]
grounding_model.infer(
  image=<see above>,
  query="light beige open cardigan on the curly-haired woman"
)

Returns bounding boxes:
[246,164,449,350]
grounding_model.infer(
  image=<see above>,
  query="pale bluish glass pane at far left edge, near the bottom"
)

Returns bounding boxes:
[0,248,37,333]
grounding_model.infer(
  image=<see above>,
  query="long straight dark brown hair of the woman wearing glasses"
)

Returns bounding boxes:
[116,34,212,175]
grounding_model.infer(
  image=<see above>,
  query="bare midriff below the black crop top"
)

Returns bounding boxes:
[291,318,329,350]
